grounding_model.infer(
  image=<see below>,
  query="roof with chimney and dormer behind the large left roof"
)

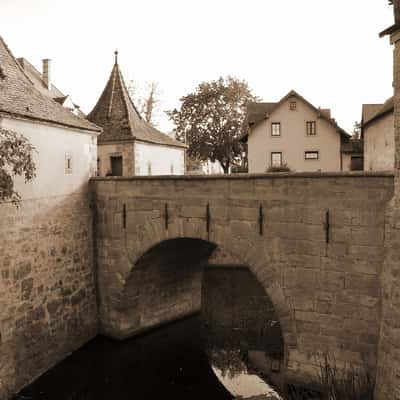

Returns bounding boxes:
[17,57,85,118]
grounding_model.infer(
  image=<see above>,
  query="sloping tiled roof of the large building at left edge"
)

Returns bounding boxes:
[0,37,101,132]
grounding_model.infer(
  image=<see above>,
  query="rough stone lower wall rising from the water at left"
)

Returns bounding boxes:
[0,191,97,400]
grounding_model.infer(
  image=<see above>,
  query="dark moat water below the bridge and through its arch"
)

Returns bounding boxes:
[16,267,283,400]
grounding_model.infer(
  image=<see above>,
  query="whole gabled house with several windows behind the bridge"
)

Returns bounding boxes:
[245,91,351,173]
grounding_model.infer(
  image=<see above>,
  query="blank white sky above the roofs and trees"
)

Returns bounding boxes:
[0,0,393,132]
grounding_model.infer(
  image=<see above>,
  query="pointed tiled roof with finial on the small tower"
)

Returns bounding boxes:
[87,53,186,147]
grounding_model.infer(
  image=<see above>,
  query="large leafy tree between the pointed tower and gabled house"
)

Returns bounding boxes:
[167,77,256,173]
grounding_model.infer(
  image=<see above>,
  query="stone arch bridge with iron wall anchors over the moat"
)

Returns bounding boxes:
[92,173,394,379]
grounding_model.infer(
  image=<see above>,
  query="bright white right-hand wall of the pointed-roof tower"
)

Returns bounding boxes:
[135,141,185,175]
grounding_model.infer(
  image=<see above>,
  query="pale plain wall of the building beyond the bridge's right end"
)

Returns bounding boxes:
[364,113,394,171]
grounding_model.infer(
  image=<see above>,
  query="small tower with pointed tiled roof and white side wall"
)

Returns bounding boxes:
[88,51,186,176]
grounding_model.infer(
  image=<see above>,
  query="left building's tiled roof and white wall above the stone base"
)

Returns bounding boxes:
[0,38,101,199]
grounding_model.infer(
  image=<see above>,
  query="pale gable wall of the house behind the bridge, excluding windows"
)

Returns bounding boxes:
[248,98,340,173]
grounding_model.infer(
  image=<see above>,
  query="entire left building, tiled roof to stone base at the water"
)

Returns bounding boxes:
[0,37,101,399]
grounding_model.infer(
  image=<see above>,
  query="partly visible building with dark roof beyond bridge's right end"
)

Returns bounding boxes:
[361,97,395,171]
